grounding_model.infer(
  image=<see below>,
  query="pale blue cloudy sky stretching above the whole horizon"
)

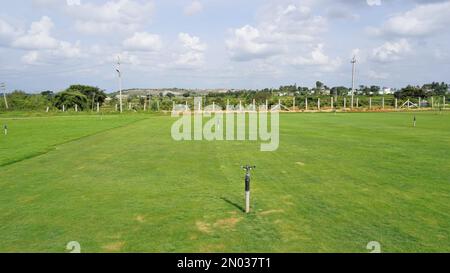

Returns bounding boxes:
[0,0,450,92]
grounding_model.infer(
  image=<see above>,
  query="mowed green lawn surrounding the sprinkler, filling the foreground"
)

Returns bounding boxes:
[0,113,450,252]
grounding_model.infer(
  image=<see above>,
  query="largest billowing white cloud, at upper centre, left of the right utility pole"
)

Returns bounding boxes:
[226,4,342,72]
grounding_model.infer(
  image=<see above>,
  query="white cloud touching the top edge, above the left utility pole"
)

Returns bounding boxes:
[66,0,154,35]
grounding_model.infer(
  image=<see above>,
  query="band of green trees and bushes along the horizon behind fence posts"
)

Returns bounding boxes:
[0,81,449,111]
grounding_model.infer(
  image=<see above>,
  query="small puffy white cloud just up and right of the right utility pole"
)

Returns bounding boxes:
[372,39,411,62]
